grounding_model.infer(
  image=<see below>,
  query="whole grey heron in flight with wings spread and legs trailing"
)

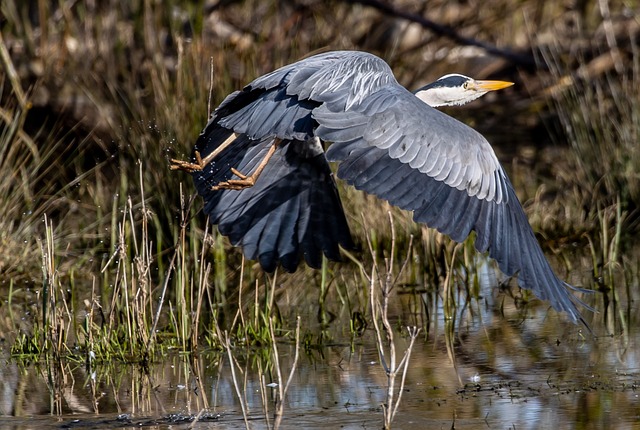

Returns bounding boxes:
[171,51,584,323]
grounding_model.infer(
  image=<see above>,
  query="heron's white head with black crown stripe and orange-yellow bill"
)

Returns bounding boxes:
[414,73,513,107]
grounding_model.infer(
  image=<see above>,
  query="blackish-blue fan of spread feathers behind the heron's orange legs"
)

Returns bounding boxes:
[193,126,354,272]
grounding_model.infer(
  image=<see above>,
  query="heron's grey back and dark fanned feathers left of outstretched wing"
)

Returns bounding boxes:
[192,51,395,271]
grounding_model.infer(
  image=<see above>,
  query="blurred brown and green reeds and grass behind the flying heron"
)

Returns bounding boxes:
[0,0,640,356]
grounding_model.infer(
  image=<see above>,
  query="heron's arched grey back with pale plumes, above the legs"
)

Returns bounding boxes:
[209,51,396,140]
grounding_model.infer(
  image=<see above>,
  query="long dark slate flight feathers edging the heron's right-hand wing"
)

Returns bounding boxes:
[338,147,582,322]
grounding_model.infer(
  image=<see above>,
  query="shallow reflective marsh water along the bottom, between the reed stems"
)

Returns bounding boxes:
[0,258,640,430]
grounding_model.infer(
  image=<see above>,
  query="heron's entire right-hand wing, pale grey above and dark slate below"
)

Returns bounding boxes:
[313,85,582,322]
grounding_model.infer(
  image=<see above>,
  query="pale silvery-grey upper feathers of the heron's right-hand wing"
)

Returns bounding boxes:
[313,85,507,202]
